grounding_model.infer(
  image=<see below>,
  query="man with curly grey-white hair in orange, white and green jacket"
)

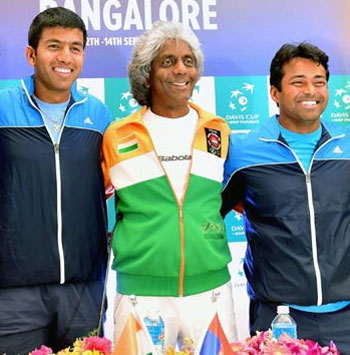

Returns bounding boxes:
[103,21,236,351]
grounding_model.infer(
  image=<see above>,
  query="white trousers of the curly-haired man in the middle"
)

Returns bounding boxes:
[113,282,237,349]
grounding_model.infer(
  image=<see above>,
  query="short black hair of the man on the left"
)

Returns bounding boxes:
[28,7,87,50]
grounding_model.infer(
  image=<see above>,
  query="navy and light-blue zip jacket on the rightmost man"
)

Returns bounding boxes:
[222,117,350,306]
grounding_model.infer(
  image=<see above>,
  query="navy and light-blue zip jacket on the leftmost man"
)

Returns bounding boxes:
[0,77,110,287]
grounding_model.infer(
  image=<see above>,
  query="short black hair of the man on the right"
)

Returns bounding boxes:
[270,42,329,91]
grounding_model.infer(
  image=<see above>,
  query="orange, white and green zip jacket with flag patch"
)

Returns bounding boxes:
[102,104,231,296]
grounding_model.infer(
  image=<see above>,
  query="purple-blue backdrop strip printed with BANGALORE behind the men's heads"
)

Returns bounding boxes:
[0,0,350,79]
